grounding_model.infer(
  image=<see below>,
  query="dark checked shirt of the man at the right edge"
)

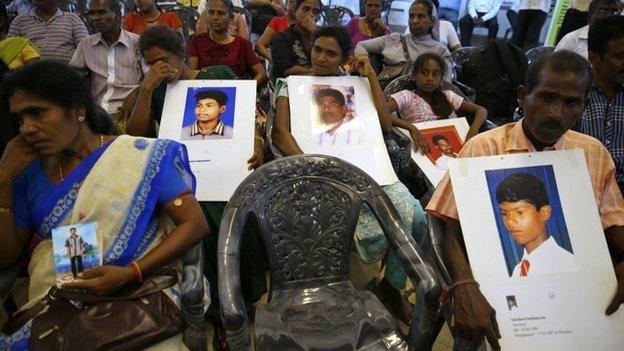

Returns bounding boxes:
[574,84,624,183]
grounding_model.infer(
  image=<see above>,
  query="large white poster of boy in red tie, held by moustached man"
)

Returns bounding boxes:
[449,150,624,351]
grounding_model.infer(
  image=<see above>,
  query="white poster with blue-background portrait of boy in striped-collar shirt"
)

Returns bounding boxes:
[158,80,256,201]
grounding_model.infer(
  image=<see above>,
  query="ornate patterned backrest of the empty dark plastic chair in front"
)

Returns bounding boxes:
[225,155,384,290]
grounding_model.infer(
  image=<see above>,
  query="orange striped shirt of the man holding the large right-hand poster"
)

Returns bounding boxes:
[427,120,624,229]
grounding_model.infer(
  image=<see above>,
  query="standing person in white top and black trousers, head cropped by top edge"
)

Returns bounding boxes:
[512,0,551,51]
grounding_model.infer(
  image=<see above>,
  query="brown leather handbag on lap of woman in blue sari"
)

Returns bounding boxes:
[3,274,184,351]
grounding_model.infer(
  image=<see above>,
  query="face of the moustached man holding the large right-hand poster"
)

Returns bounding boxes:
[518,68,588,147]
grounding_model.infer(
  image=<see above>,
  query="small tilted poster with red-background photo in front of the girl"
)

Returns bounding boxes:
[401,117,470,187]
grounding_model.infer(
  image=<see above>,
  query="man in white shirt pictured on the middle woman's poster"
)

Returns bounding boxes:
[314,88,360,146]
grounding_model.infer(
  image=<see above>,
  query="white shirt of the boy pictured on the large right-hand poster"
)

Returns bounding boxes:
[511,236,577,277]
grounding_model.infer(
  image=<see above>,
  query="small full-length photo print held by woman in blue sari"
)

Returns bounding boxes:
[52,222,102,287]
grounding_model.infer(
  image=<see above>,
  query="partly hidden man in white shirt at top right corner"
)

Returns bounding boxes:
[555,0,620,58]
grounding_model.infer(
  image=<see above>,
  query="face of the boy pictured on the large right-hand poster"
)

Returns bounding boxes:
[499,200,551,245]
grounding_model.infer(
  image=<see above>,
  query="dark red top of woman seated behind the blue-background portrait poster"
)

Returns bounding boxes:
[189,33,260,79]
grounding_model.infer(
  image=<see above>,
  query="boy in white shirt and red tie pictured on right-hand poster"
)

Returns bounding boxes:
[496,173,576,277]
